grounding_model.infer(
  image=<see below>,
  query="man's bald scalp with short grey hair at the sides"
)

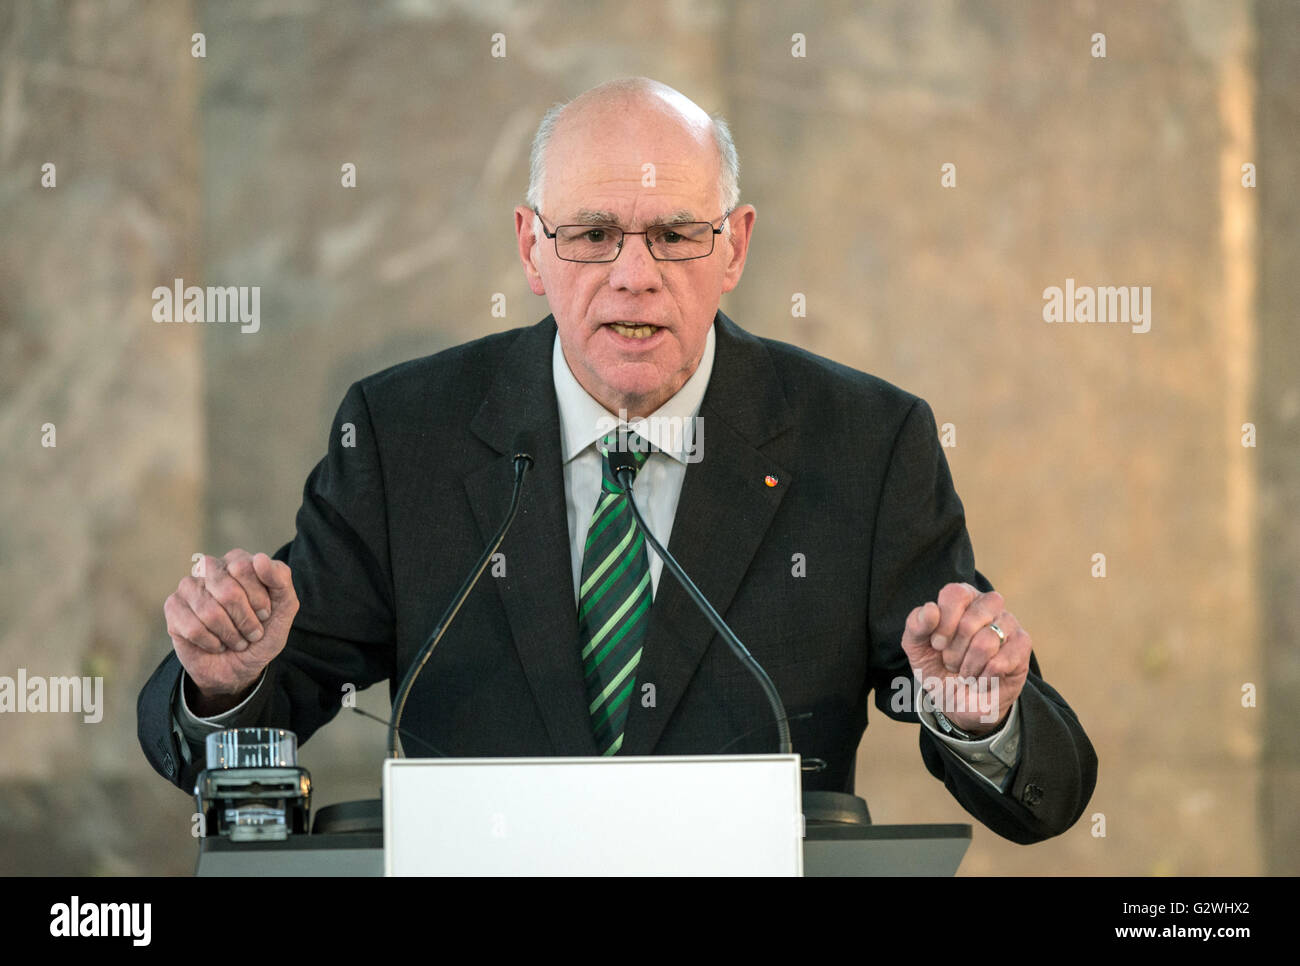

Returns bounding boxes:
[527,77,740,211]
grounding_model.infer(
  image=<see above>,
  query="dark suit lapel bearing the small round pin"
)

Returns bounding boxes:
[621,312,793,755]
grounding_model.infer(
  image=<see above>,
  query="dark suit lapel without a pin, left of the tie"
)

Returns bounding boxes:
[465,316,597,755]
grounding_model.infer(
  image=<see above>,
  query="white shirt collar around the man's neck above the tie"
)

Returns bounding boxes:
[551,325,715,464]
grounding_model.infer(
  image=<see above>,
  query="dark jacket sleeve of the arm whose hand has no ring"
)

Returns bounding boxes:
[137,384,395,789]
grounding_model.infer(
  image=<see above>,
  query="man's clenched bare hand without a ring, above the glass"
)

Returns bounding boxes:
[163,550,298,718]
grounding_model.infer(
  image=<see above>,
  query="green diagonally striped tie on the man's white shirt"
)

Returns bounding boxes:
[577,434,650,755]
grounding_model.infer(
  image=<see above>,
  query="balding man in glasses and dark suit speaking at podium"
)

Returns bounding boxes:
[139,79,1096,842]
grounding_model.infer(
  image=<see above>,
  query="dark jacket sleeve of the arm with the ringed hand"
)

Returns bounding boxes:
[868,399,1097,844]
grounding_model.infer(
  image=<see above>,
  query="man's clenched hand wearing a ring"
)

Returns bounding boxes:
[902,584,1034,737]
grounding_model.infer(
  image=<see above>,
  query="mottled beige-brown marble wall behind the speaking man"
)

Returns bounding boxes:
[0,0,1300,875]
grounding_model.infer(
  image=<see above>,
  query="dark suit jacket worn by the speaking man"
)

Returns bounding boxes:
[138,313,1096,842]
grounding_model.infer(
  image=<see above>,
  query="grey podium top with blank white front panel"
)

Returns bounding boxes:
[189,755,971,876]
